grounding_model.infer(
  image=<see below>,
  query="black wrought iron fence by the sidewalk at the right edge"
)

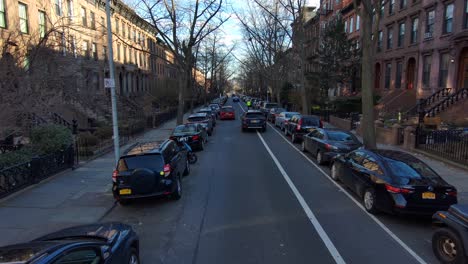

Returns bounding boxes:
[416,129,468,165]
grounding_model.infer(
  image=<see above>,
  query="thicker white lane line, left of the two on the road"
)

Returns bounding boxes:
[257,131,346,264]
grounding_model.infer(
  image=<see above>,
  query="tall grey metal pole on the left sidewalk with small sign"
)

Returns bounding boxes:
[106,0,120,164]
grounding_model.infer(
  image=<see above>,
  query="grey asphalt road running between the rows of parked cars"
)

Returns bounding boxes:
[103,99,437,264]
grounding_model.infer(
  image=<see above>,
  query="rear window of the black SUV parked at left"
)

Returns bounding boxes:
[117,154,164,172]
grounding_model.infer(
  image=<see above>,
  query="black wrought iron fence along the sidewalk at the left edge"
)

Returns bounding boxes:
[0,146,74,198]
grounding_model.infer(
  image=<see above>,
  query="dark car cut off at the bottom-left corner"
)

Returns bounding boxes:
[0,222,140,264]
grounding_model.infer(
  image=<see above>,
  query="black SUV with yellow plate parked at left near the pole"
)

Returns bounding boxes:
[112,140,190,205]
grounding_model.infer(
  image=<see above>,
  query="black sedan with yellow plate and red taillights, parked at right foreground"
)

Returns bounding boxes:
[331,149,457,215]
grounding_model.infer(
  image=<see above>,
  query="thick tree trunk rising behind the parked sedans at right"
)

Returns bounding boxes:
[361,11,378,148]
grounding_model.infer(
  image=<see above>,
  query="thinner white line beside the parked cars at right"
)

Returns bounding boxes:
[264,121,427,264]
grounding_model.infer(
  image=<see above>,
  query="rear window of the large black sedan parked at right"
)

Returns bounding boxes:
[385,158,439,179]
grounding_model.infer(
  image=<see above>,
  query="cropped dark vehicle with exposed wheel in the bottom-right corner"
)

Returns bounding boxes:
[432,204,468,264]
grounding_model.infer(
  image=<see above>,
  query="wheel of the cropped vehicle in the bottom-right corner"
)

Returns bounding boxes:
[432,228,467,264]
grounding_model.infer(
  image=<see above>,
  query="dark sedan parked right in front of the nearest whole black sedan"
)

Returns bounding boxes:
[301,128,362,164]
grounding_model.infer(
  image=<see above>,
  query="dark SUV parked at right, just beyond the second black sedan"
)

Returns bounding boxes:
[284,115,323,143]
